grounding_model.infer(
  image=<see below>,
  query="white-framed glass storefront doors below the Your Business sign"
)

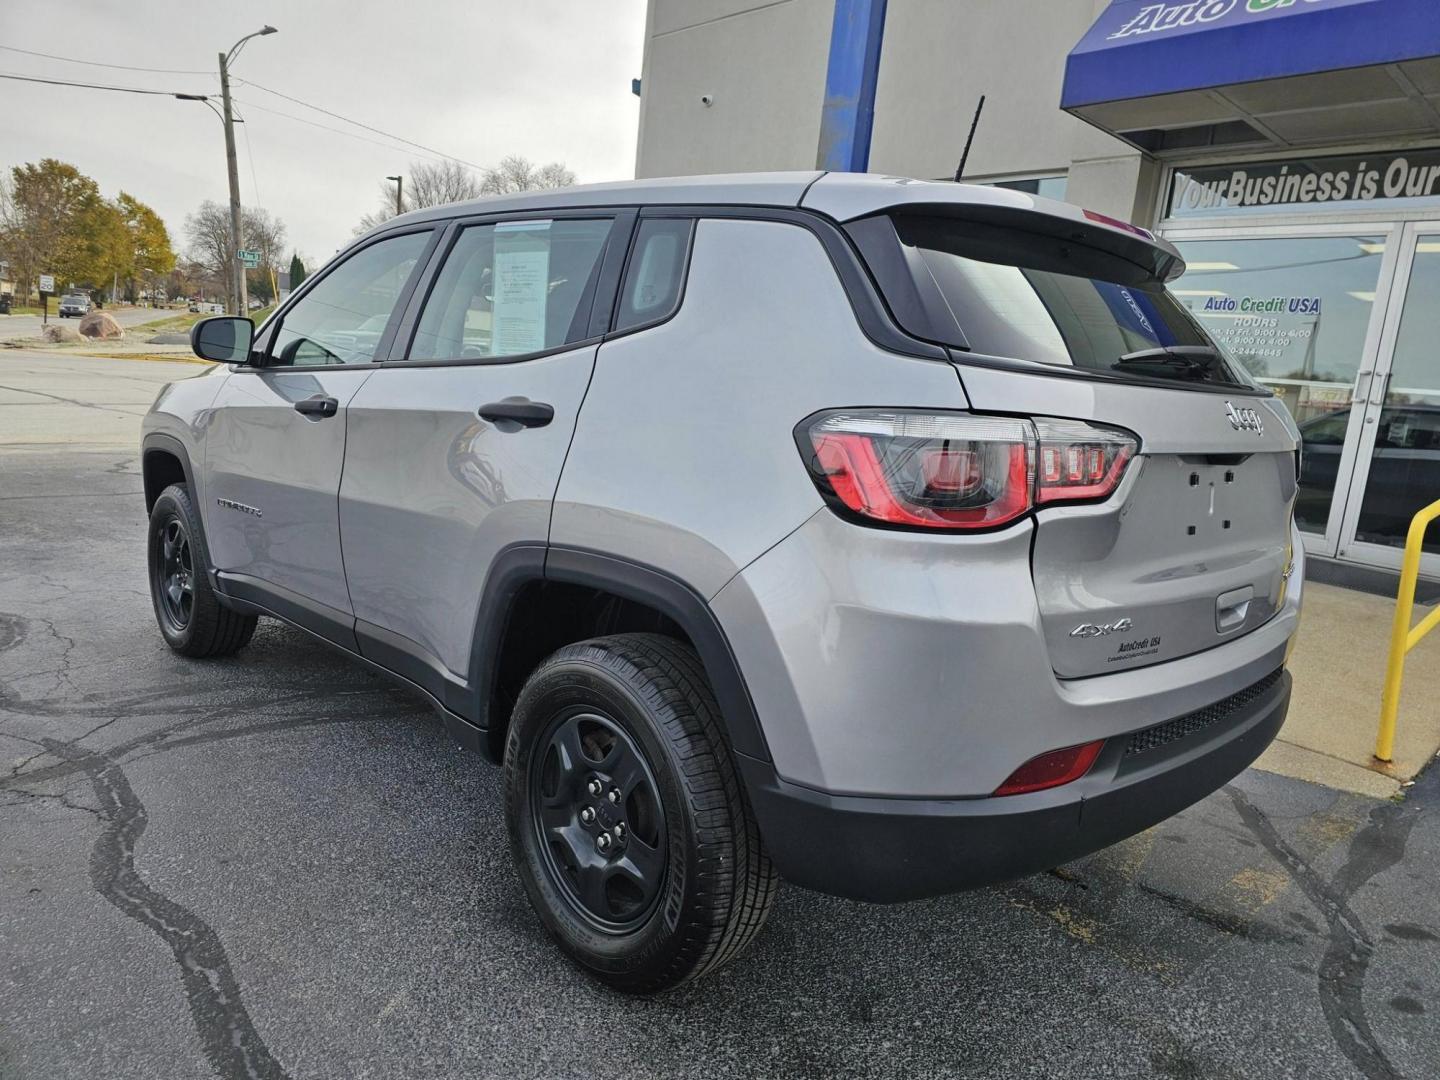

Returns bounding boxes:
[1169,223,1440,573]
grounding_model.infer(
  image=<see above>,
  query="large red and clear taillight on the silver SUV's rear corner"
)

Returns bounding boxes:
[798,409,1138,530]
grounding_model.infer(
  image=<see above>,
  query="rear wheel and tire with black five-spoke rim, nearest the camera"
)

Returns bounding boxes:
[505,634,778,994]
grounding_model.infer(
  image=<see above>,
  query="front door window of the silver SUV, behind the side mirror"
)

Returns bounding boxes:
[269,232,431,367]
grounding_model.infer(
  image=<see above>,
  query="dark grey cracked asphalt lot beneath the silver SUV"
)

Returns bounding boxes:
[0,351,1440,1080]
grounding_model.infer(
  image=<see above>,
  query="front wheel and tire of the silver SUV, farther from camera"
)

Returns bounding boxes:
[145,484,256,657]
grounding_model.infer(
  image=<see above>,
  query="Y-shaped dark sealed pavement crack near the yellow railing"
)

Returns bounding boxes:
[1225,785,1418,1080]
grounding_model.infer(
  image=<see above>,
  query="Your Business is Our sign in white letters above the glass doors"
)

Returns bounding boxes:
[1169,150,1440,217]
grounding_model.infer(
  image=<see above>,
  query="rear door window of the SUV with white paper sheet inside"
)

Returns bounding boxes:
[408,217,612,360]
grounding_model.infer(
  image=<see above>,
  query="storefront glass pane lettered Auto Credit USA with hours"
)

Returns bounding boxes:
[1171,235,1388,533]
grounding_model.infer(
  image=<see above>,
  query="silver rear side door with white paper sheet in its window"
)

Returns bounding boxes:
[340,212,634,702]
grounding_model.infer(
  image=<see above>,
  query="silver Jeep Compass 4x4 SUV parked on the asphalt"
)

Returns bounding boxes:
[144,173,1303,992]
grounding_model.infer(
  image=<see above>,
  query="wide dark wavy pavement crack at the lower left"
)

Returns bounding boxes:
[46,739,288,1080]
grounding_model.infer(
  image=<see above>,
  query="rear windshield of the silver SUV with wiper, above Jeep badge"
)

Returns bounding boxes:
[857,215,1254,387]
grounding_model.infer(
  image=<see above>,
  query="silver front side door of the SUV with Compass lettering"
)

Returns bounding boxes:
[204,229,435,648]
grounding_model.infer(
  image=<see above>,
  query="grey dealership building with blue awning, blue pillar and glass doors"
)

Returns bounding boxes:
[636,0,1440,577]
